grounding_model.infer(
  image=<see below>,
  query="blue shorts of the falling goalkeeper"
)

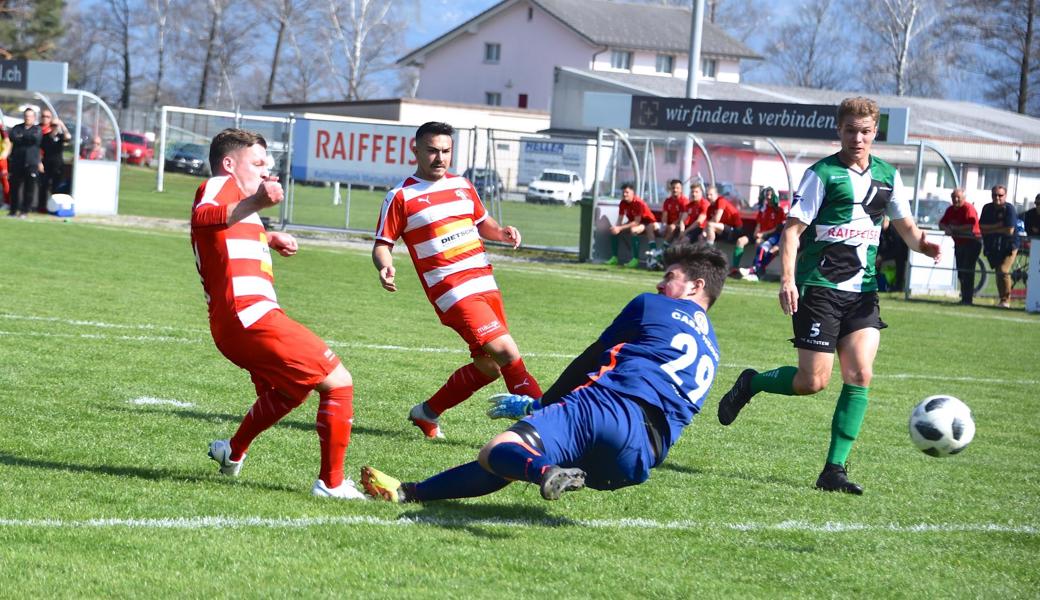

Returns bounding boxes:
[524,384,654,490]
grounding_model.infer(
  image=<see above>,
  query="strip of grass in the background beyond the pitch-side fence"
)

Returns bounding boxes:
[120,165,580,253]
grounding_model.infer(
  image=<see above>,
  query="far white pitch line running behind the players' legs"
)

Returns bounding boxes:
[0,313,1040,385]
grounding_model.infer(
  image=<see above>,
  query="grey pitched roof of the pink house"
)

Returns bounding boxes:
[397,0,762,63]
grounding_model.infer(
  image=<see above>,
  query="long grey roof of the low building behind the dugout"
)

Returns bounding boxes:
[561,68,1040,145]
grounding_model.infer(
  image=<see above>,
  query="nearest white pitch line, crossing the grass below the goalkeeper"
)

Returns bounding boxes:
[0,515,1040,536]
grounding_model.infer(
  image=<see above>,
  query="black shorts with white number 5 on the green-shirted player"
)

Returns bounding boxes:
[790,286,888,354]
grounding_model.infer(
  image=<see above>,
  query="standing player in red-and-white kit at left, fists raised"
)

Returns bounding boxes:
[191,129,365,500]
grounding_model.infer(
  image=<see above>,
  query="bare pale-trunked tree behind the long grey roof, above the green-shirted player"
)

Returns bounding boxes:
[848,0,946,96]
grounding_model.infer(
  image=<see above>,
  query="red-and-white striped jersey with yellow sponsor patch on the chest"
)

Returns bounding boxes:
[375,174,498,314]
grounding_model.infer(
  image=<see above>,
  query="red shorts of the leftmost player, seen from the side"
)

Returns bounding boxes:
[213,310,339,399]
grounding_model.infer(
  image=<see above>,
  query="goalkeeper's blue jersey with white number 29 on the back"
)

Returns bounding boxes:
[589,293,719,445]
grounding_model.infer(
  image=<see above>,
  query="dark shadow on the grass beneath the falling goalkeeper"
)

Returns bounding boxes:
[393,494,580,540]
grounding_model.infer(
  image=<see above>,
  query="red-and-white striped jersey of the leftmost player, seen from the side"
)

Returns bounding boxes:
[191,176,281,335]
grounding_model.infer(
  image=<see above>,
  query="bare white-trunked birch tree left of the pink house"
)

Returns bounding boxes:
[327,0,401,100]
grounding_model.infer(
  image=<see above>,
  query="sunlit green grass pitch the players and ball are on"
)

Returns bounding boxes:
[0,207,1040,598]
